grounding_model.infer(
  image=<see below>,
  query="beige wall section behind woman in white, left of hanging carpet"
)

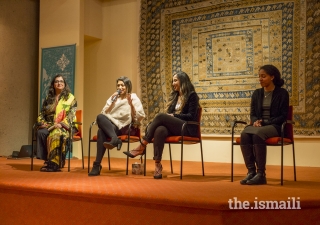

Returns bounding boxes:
[84,0,140,157]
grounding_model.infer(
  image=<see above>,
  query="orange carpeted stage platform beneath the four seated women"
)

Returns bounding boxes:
[0,157,320,225]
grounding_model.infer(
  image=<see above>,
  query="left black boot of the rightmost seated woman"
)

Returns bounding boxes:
[240,145,256,184]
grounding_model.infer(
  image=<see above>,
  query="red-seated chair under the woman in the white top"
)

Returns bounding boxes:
[88,122,146,175]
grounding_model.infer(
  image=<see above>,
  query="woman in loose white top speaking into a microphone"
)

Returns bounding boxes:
[88,77,145,176]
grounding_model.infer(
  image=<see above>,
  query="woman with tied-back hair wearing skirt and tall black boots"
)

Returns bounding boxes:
[240,65,289,185]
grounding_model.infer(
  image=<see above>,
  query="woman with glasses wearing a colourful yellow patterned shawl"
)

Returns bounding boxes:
[37,74,77,172]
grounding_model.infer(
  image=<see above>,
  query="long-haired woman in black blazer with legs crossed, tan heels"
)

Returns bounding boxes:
[123,72,199,179]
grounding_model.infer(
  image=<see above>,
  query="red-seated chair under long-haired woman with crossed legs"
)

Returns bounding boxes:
[146,107,204,179]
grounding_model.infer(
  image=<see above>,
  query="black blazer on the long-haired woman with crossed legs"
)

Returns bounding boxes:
[167,92,199,136]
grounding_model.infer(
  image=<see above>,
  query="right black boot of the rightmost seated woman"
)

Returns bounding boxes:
[247,144,267,185]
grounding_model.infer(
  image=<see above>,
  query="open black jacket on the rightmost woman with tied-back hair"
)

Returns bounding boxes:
[250,86,289,133]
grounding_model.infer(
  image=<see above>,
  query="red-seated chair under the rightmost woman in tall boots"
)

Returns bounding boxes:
[231,106,297,185]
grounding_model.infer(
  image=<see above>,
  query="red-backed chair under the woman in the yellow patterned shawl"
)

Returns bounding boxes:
[30,110,84,172]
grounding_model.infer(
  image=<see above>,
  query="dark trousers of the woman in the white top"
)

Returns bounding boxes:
[95,114,121,164]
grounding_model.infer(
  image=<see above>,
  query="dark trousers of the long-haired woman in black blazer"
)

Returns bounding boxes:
[143,113,189,160]
